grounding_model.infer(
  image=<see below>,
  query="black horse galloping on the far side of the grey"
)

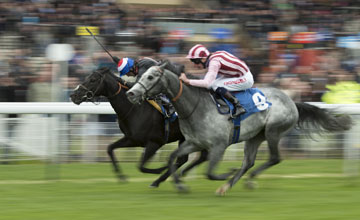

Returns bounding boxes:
[70,67,188,187]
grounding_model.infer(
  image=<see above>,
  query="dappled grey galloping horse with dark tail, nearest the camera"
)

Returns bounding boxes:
[127,65,352,195]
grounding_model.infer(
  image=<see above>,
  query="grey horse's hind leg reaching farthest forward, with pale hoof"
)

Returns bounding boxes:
[216,132,265,195]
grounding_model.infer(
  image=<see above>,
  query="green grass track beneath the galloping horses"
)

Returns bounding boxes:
[0,159,360,220]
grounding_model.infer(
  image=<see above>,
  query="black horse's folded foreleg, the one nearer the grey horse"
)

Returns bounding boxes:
[139,142,168,174]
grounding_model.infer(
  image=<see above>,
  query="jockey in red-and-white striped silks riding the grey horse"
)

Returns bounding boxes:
[180,44,254,118]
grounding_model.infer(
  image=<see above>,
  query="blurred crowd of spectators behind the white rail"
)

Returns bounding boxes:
[0,0,360,103]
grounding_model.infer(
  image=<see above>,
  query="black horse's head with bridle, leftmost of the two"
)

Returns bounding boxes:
[70,67,116,105]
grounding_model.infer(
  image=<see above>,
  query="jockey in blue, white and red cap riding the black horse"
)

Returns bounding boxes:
[117,57,184,117]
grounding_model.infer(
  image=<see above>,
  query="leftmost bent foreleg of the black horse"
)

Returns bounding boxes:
[107,137,136,181]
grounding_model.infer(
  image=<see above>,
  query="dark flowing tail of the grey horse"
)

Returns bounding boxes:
[295,103,353,133]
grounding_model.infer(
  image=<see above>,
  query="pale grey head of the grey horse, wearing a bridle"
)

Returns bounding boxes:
[126,63,166,103]
